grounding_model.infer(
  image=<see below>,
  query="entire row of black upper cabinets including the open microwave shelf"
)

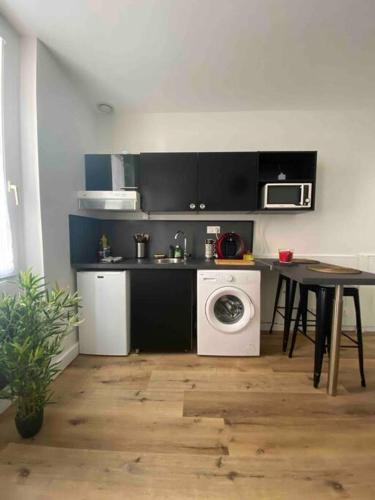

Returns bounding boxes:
[85,151,317,212]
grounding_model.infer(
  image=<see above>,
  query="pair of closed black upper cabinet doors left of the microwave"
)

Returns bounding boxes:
[139,149,258,212]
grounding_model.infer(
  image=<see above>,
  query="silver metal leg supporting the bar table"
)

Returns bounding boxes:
[327,285,343,396]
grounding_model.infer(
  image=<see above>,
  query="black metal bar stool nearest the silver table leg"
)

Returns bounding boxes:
[289,285,366,387]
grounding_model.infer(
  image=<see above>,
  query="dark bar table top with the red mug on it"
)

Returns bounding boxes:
[258,259,375,286]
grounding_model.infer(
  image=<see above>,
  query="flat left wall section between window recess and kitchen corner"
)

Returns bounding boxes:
[37,41,97,349]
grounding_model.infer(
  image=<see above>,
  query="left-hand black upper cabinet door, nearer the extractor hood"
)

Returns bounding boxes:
[139,153,198,212]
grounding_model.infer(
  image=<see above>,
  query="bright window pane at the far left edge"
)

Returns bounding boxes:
[0,38,15,278]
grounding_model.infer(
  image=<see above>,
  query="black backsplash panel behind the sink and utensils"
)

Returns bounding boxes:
[69,215,254,263]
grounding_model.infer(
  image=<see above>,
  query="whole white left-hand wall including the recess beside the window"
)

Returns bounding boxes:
[0,27,97,412]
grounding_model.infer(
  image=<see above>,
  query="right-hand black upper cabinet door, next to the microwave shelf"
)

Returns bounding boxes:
[198,153,258,211]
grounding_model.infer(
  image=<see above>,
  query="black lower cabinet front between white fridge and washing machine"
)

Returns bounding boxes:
[131,269,195,352]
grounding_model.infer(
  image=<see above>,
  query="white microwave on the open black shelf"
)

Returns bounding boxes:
[262,182,312,208]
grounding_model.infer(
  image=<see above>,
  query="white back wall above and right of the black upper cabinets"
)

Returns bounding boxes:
[97,110,375,327]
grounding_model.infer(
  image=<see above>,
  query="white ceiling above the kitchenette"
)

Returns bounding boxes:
[0,0,375,112]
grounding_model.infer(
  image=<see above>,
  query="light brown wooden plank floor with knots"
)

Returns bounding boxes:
[0,334,375,500]
